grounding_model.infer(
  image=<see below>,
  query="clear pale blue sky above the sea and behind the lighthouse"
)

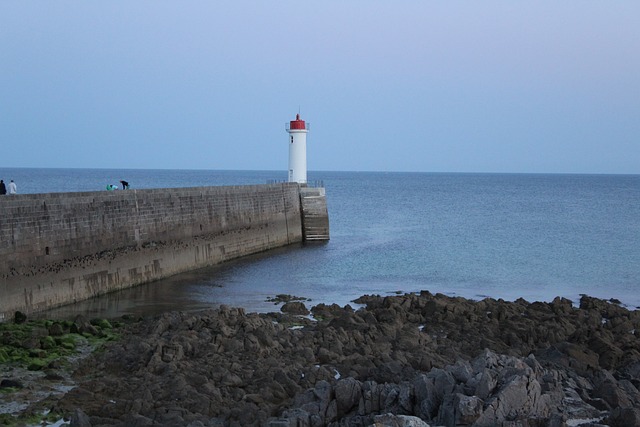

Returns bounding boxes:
[0,0,640,174]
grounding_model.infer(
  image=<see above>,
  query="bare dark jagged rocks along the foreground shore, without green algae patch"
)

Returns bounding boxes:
[3,291,640,427]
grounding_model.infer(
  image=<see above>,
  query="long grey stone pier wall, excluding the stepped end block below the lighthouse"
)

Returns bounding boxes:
[0,183,303,321]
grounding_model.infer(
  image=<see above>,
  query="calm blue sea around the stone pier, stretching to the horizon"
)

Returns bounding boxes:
[0,168,640,317]
